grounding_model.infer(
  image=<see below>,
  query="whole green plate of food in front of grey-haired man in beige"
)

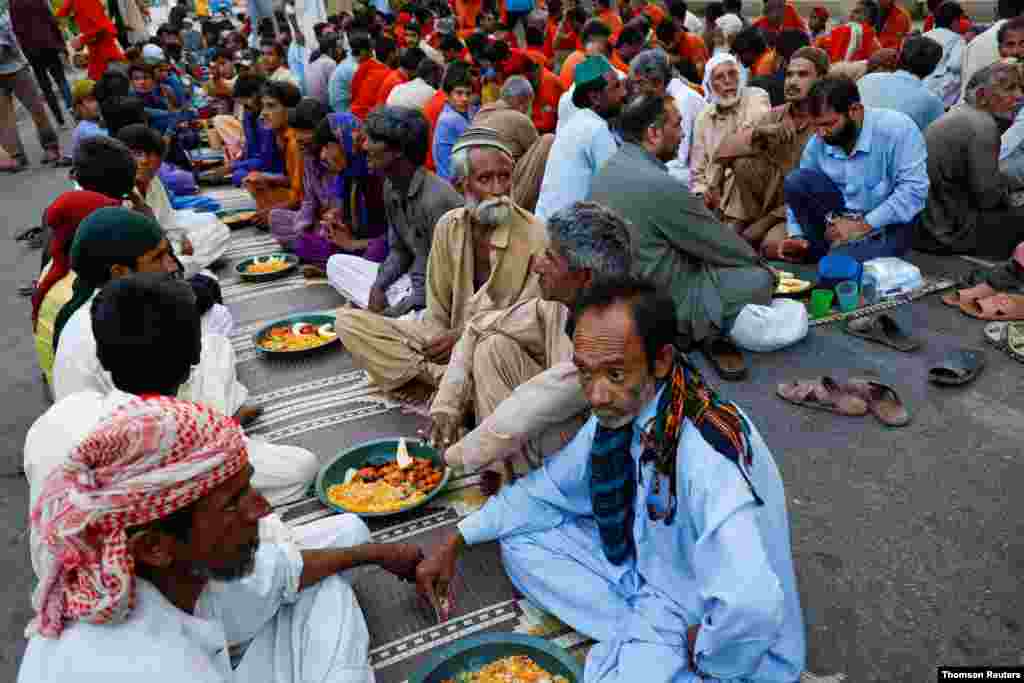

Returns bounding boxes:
[316,437,451,517]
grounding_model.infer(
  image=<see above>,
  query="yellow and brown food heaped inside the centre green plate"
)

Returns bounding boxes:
[327,458,444,512]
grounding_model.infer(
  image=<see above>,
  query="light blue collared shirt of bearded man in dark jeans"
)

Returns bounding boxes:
[785,109,928,237]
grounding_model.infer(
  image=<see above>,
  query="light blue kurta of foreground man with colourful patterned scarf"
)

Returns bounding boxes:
[459,388,805,683]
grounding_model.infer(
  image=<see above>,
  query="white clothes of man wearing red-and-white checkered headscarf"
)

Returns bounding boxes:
[17,515,374,683]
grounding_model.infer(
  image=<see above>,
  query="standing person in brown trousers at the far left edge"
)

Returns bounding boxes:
[0,10,60,173]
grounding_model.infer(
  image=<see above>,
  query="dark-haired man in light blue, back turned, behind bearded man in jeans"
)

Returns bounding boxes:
[857,36,946,133]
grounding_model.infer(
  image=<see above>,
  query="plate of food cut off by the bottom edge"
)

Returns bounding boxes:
[409,633,583,683]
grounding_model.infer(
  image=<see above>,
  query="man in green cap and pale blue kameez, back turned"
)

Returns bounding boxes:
[534,56,626,220]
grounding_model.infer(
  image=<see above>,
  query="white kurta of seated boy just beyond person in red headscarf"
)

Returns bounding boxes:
[145,178,231,278]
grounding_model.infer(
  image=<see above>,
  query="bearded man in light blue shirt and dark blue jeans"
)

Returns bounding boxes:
[779,77,929,262]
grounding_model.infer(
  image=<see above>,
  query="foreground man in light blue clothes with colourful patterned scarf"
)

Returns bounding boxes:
[417,281,806,683]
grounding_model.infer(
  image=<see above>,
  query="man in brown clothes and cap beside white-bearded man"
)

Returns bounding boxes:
[715,47,828,247]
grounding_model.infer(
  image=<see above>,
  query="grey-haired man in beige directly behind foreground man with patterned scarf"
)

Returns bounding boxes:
[430,202,630,494]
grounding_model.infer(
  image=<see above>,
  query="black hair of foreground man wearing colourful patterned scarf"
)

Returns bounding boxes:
[574,276,679,373]
